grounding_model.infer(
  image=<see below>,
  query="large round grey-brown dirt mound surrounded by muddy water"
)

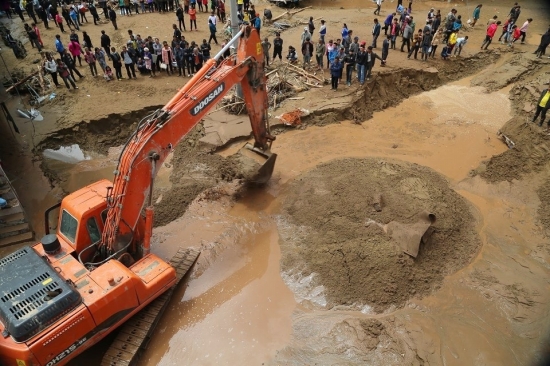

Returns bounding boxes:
[281,159,481,311]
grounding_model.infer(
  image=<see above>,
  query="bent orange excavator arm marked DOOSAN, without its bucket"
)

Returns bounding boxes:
[99,26,276,255]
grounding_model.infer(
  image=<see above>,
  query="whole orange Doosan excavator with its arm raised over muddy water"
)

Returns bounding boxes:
[0,26,277,366]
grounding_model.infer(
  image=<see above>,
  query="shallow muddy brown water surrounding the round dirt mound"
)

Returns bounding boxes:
[56,76,546,365]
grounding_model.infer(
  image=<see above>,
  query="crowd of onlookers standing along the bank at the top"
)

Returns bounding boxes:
[2,0,550,90]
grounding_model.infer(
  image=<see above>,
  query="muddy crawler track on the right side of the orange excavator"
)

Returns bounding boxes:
[101,248,200,366]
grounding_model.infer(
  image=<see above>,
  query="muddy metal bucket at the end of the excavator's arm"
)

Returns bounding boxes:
[236,142,277,184]
